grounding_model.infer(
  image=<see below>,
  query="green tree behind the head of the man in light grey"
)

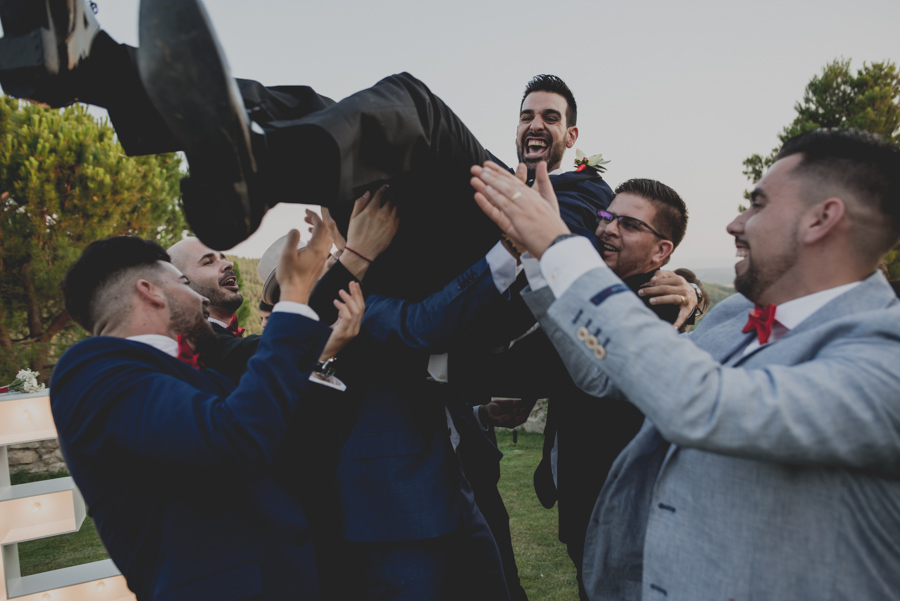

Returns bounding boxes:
[738,59,900,279]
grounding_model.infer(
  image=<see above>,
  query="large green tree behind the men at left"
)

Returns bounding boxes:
[0,97,186,382]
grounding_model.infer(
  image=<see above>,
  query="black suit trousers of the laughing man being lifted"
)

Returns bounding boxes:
[94,36,499,300]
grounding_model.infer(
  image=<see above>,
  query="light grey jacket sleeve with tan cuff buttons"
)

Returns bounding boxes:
[544,268,900,476]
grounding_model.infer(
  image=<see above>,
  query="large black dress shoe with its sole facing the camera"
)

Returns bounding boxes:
[138,0,268,250]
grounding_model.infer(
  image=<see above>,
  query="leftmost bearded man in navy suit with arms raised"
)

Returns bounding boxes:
[51,226,354,600]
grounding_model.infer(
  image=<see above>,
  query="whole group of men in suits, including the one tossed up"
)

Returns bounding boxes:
[0,0,900,601]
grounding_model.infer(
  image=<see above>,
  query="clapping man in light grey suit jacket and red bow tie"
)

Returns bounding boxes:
[473,130,900,601]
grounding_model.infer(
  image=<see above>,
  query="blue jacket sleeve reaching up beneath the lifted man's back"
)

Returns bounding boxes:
[362,258,507,353]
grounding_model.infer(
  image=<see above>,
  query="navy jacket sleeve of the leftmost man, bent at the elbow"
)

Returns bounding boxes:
[51,313,330,473]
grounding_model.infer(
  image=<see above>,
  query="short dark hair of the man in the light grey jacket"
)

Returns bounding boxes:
[776,128,900,246]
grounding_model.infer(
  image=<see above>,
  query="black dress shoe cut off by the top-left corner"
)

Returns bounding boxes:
[0,0,100,107]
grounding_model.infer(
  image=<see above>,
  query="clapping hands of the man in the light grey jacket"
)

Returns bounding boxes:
[471,162,569,259]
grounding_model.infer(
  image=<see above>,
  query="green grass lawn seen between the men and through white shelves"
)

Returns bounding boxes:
[12,430,578,601]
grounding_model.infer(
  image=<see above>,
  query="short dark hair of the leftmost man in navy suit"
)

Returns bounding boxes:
[61,236,170,332]
